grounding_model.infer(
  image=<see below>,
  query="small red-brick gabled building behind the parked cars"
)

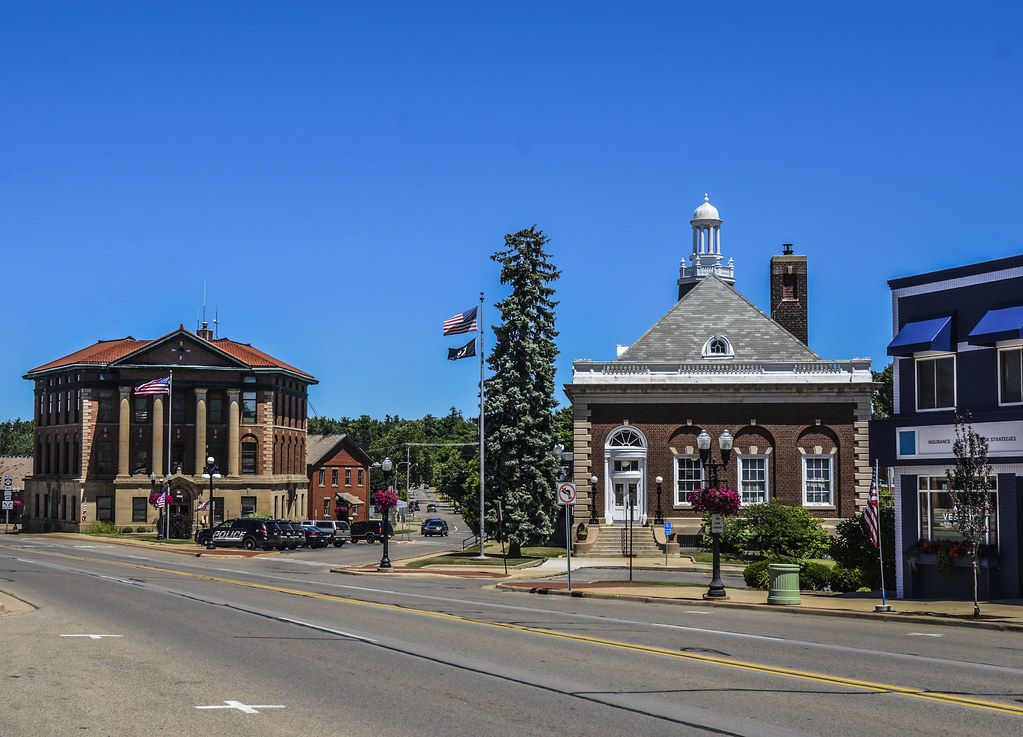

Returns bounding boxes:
[306,434,373,520]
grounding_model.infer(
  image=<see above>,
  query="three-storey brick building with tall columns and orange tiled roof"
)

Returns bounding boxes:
[24,323,316,532]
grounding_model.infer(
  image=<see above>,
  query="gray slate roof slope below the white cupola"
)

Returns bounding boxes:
[617,274,820,363]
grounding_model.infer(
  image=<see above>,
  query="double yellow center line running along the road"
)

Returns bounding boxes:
[14,549,1023,717]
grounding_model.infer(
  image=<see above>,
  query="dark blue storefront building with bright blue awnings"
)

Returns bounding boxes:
[871,256,1023,599]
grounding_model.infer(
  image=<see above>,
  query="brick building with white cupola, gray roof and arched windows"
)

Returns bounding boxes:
[565,199,876,533]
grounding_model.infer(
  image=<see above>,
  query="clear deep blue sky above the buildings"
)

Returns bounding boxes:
[0,0,1023,420]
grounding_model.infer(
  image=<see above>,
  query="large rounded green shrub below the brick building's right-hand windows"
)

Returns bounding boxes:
[743,502,832,559]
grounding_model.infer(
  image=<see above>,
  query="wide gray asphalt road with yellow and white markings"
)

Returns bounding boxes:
[0,535,1023,737]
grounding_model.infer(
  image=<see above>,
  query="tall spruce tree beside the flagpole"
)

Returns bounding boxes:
[484,225,561,557]
